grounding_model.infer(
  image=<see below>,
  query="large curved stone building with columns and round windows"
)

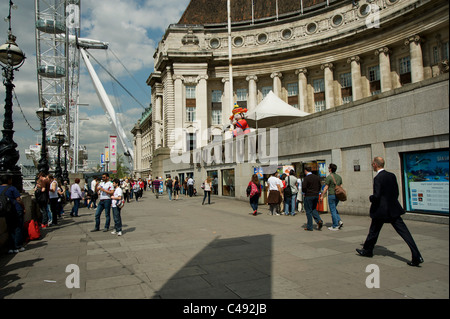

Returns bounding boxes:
[139,0,449,219]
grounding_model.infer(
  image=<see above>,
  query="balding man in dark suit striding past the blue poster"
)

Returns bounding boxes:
[356,157,423,266]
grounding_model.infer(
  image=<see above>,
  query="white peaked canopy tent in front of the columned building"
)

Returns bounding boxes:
[245,91,309,128]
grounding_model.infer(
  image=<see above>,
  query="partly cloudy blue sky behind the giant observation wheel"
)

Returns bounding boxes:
[0,0,189,171]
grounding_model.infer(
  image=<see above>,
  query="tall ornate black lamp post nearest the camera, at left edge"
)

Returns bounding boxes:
[0,1,25,192]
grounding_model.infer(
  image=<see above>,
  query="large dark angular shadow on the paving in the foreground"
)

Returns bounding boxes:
[153,235,272,299]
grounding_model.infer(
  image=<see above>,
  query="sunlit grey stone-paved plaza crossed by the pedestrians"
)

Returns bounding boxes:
[0,192,449,299]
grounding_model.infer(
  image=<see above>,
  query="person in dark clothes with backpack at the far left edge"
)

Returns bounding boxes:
[0,175,25,254]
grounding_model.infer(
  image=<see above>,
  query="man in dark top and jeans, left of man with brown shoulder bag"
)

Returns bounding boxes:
[302,165,323,231]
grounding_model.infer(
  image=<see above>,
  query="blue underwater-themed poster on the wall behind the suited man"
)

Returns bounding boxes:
[403,150,449,215]
